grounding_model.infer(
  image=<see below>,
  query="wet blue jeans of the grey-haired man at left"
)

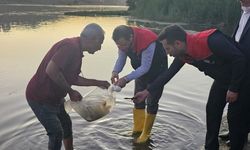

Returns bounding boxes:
[28,100,72,150]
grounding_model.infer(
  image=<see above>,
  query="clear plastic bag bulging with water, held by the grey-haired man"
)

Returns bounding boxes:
[65,87,115,121]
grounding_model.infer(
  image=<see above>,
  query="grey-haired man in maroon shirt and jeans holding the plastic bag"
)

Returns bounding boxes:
[26,23,110,150]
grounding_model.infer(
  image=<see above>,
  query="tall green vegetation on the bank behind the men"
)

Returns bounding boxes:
[127,0,240,26]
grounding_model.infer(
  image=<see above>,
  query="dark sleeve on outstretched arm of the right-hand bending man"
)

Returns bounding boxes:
[147,58,185,93]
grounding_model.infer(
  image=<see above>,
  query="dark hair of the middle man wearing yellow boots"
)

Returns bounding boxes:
[112,25,133,41]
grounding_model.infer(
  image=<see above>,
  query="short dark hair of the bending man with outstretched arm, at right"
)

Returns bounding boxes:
[158,25,187,44]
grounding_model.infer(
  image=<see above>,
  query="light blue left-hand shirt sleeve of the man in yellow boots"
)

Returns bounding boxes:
[113,50,127,73]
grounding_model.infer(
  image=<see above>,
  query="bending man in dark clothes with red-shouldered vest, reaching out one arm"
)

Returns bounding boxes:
[134,25,246,150]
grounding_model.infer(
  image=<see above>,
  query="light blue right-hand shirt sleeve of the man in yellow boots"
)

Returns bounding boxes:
[126,42,156,82]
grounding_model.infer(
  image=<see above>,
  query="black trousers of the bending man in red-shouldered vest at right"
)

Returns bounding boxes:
[205,81,249,150]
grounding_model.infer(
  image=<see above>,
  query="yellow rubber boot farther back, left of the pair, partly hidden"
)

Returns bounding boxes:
[132,108,145,136]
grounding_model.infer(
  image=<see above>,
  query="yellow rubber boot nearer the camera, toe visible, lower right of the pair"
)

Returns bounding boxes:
[135,114,156,144]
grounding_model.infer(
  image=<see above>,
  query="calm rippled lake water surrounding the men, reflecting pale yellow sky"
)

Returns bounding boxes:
[0,5,212,150]
